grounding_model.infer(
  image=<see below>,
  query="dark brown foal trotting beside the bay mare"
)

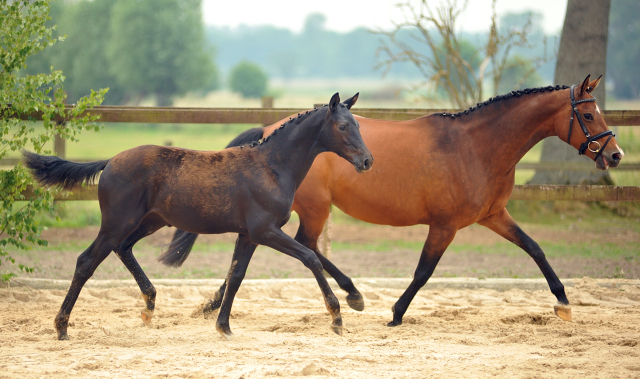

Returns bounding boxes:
[24,93,373,340]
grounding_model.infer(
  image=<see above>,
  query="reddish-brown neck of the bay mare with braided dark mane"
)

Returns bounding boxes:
[463,90,569,169]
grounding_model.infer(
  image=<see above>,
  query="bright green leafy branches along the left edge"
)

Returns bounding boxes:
[0,0,107,281]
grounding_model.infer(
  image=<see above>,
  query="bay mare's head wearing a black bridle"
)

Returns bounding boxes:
[555,75,624,170]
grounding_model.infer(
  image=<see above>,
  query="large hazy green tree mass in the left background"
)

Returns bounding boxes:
[29,0,219,105]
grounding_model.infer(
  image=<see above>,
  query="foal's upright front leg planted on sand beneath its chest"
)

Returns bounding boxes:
[215,234,258,340]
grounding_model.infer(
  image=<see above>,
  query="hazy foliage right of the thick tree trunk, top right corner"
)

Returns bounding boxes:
[607,0,640,99]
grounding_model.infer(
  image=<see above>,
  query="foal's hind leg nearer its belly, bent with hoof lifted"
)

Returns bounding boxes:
[114,216,166,325]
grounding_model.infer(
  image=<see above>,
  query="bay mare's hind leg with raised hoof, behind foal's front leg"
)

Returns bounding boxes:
[293,202,364,311]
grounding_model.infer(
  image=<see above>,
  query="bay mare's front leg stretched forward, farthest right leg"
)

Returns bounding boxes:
[478,208,572,321]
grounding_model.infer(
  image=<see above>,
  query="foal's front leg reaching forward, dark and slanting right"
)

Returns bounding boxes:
[255,226,342,335]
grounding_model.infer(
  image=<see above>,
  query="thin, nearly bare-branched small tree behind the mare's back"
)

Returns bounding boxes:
[378,0,545,108]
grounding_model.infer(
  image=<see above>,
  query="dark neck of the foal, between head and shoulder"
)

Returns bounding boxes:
[261,108,326,188]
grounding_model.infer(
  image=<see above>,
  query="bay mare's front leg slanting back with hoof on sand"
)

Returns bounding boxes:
[387,225,458,326]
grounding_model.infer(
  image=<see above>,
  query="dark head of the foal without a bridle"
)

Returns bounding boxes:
[318,93,373,172]
